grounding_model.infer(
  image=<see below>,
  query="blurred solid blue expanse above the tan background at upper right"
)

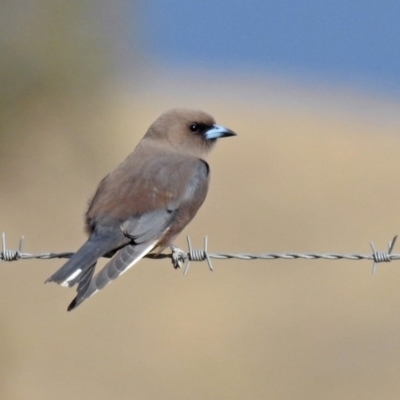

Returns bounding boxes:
[140,0,400,96]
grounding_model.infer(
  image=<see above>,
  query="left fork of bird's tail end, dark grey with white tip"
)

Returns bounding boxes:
[45,239,109,286]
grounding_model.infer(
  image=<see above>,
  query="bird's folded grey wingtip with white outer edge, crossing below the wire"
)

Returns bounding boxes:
[68,241,157,311]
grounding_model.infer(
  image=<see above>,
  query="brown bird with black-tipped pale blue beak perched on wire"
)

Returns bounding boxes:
[45,109,236,311]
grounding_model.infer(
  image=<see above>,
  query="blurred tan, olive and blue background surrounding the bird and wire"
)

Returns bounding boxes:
[0,0,400,400]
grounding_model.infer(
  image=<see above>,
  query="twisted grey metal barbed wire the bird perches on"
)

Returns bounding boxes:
[0,232,400,275]
